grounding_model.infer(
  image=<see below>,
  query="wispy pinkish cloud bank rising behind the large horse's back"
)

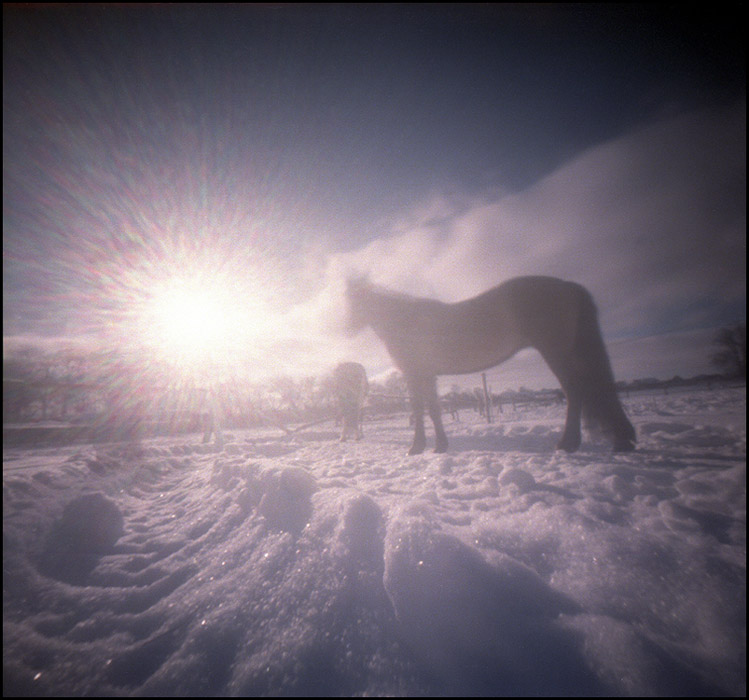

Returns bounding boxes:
[297,102,746,386]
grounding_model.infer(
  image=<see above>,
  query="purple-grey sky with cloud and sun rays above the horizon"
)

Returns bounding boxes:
[3,3,746,388]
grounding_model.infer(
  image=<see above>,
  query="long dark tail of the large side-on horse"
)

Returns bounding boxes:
[575,290,637,451]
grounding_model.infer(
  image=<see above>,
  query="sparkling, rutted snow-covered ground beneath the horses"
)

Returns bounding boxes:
[3,388,746,697]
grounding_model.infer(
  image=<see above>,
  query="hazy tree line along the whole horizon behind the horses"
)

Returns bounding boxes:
[3,323,746,432]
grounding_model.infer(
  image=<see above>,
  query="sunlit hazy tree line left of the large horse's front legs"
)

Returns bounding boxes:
[3,347,406,432]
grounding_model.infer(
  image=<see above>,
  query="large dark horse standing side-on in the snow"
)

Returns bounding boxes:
[346,277,636,455]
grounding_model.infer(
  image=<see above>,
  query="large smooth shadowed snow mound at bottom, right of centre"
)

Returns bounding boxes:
[384,504,604,695]
